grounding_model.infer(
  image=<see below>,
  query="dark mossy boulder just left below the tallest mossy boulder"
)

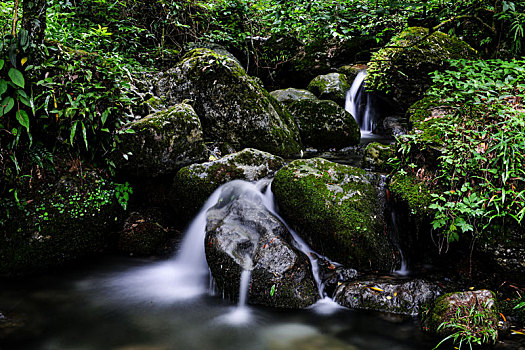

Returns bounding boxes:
[114,103,207,178]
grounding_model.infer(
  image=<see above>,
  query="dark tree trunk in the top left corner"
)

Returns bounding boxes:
[22,0,47,45]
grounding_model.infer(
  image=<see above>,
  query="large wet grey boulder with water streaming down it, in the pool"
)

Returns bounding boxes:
[205,181,319,308]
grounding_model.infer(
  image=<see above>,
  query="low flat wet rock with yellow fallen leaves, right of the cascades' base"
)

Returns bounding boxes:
[334,279,442,316]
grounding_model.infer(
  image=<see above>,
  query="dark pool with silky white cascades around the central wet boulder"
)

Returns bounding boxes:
[0,182,433,350]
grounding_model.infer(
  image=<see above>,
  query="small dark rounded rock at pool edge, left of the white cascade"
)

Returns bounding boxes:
[118,208,168,256]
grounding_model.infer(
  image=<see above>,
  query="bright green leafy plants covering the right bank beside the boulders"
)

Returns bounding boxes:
[398,60,525,247]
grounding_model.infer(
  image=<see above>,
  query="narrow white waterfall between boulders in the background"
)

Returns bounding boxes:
[345,70,374,132]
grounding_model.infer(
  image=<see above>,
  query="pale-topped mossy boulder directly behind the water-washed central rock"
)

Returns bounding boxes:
[173,148,284,217]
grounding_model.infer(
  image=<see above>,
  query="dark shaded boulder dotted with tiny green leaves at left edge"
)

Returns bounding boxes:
[0,171,122,275]
